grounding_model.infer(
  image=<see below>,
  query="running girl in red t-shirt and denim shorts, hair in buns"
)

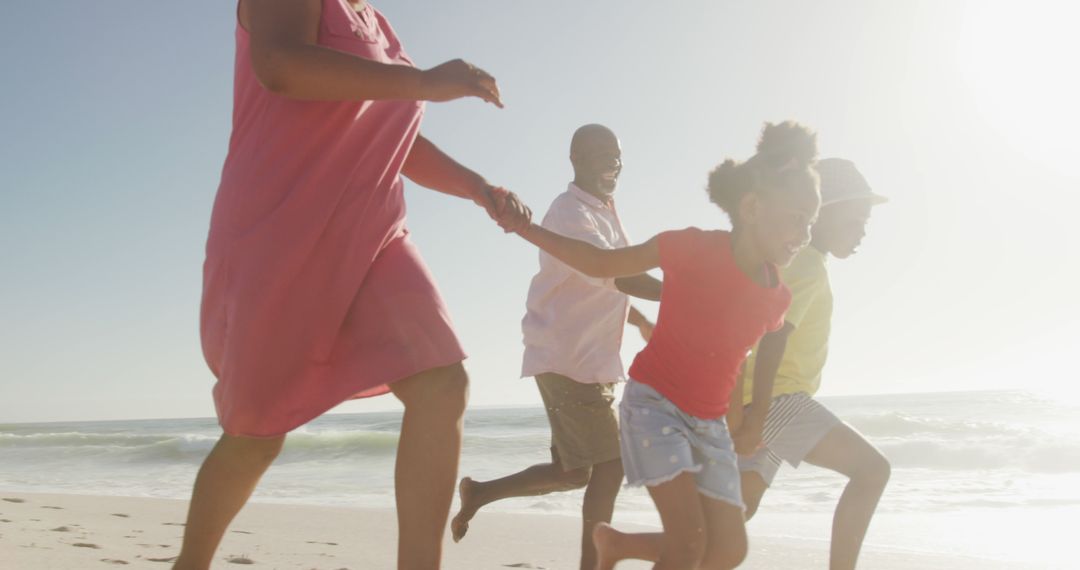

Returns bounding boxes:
[519,122,821,569]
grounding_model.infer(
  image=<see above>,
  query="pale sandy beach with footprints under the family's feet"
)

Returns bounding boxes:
[0,492,1032,570]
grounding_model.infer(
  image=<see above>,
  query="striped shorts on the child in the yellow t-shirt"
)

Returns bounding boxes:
[739,392,840,485]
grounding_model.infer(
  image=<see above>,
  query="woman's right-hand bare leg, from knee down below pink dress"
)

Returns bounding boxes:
[390,363,469,570]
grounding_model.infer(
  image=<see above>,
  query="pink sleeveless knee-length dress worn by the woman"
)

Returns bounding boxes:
[201,0,465,437]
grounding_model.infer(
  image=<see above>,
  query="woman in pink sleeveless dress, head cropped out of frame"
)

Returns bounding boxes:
[175,0,530,570]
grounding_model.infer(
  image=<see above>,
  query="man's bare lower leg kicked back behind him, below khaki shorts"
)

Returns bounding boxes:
[450,449,596,542]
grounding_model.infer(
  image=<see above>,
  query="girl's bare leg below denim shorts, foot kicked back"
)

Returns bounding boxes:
[594,473,707,570]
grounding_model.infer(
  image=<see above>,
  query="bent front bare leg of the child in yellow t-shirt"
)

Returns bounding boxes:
[806,423,890,570]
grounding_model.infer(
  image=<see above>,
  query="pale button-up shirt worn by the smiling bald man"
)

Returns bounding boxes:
[522,182,630,383]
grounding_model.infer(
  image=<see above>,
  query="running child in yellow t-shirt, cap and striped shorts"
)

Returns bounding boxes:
[728,159,889,570]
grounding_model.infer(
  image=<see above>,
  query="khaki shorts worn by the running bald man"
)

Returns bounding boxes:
[536,372,620,471]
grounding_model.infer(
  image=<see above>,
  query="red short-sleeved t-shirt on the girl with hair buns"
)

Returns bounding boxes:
[630,228,792,419]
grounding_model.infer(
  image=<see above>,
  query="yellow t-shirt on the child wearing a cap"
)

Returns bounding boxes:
[743,246,833,404]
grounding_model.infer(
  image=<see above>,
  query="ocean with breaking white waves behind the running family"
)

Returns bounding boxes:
[0,392,1080,568]
